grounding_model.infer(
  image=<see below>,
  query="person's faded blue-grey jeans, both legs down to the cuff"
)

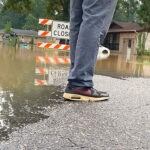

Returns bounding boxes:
[68,0,118,87]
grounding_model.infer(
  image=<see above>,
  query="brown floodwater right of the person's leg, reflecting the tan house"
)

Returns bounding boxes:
[96,54,150,77]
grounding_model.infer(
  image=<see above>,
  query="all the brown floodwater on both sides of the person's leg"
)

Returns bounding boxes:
[0,44,150,140]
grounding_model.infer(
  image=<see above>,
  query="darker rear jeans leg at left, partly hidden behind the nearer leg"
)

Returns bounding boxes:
[70,0,83,71]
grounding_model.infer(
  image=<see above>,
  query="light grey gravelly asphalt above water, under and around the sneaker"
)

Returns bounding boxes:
[0,76,150,150]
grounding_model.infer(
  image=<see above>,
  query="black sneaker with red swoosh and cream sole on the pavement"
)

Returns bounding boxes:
[63,85,109,101]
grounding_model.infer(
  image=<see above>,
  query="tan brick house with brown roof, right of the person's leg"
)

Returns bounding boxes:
[103,21,150,54]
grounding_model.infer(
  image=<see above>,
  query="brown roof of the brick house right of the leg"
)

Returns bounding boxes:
[109,21,144,32]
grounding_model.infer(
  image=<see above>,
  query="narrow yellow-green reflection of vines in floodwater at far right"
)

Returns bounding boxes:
[134,56,145,77]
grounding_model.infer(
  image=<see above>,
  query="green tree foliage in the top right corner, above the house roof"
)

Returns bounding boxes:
[137,0,150,31]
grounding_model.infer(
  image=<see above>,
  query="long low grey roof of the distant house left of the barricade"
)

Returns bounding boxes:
[0,29,38,36]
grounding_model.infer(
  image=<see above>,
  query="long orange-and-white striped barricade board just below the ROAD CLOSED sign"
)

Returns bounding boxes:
[37,42,70,50]
